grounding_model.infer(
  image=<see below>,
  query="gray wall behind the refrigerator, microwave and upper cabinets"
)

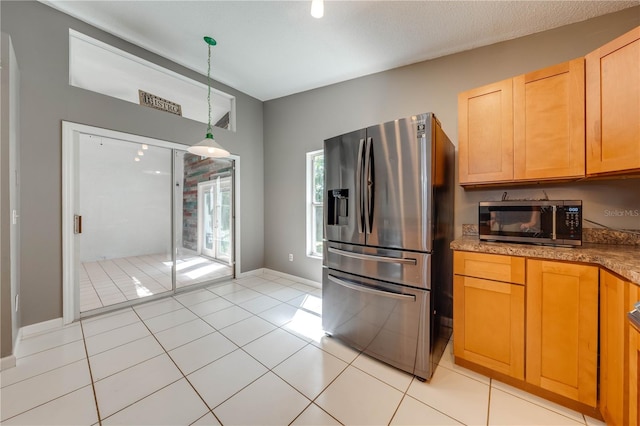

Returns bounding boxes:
[264,7,640,281]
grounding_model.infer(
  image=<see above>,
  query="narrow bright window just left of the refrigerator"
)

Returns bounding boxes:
[307,150,324,258]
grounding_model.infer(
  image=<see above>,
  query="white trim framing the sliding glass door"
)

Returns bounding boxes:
[62,121,241,325]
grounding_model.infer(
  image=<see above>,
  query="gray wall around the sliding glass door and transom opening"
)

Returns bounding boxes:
[0,1,264,326]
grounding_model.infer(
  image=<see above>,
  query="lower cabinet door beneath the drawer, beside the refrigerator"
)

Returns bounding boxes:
[453,275,524,380]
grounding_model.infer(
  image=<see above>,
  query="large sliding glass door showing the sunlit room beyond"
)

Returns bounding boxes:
[74,133,234,314]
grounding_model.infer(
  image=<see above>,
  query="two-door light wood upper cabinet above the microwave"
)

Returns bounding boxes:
[458,58,585,185]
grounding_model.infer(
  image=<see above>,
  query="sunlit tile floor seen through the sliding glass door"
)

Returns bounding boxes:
[80,252,232,312]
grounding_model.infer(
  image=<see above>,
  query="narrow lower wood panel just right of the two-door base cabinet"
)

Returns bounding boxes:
[600,270,631,425]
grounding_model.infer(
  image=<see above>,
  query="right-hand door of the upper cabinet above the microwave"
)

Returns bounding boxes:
[513,58,585,180]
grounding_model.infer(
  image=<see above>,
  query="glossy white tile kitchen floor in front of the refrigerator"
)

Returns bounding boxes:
[0,274,602,425]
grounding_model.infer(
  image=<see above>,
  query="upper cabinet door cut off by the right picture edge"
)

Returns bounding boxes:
[586,27,640,174]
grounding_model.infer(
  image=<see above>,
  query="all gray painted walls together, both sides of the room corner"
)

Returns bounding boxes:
[0,1,640,342]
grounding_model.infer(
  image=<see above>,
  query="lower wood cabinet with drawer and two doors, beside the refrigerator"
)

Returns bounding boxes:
[453,251,599,415]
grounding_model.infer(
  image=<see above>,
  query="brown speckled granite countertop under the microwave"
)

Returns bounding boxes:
[450,231,640,285]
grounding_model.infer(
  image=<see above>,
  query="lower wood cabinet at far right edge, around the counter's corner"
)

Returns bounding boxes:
[600,270,640,426]
